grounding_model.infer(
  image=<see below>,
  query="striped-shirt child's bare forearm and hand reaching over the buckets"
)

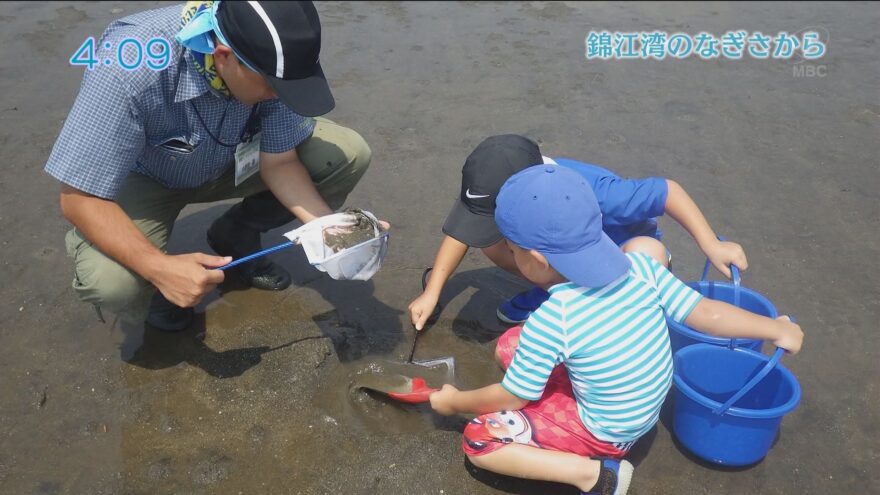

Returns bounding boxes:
[685,298,804,354]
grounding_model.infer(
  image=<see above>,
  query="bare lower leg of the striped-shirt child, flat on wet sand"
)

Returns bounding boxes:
[468,443,601,492]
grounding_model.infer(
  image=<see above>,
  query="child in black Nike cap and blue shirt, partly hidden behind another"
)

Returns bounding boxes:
[409,134,748,330]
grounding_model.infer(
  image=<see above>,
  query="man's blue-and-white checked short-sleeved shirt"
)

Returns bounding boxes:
[45,5,315,199]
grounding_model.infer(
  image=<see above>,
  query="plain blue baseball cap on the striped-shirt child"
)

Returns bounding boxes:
[495,165,631,287]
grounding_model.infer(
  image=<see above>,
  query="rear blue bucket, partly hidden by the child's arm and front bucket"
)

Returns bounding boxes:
[666,260,779,353]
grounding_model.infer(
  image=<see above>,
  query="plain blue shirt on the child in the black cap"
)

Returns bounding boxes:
[553,158,669,245]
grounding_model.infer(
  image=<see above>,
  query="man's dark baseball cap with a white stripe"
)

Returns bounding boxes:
[216,1,336,117]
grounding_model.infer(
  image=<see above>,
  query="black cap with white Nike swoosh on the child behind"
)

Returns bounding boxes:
[443,134,544,248]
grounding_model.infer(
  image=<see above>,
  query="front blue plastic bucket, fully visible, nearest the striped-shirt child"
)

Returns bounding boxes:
[673,344,801,466]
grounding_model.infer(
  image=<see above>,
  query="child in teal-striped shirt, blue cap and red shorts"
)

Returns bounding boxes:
[431,165,803,494]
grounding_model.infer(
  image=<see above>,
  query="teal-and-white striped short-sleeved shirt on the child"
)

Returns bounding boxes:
[501,253,702,443]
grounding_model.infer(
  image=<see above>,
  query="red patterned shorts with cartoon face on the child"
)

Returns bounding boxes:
[461,327,632,458]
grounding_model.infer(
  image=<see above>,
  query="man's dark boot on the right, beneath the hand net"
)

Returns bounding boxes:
[208,215,291,290]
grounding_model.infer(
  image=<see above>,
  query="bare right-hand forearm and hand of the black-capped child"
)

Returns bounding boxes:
[665,179,749,278]
